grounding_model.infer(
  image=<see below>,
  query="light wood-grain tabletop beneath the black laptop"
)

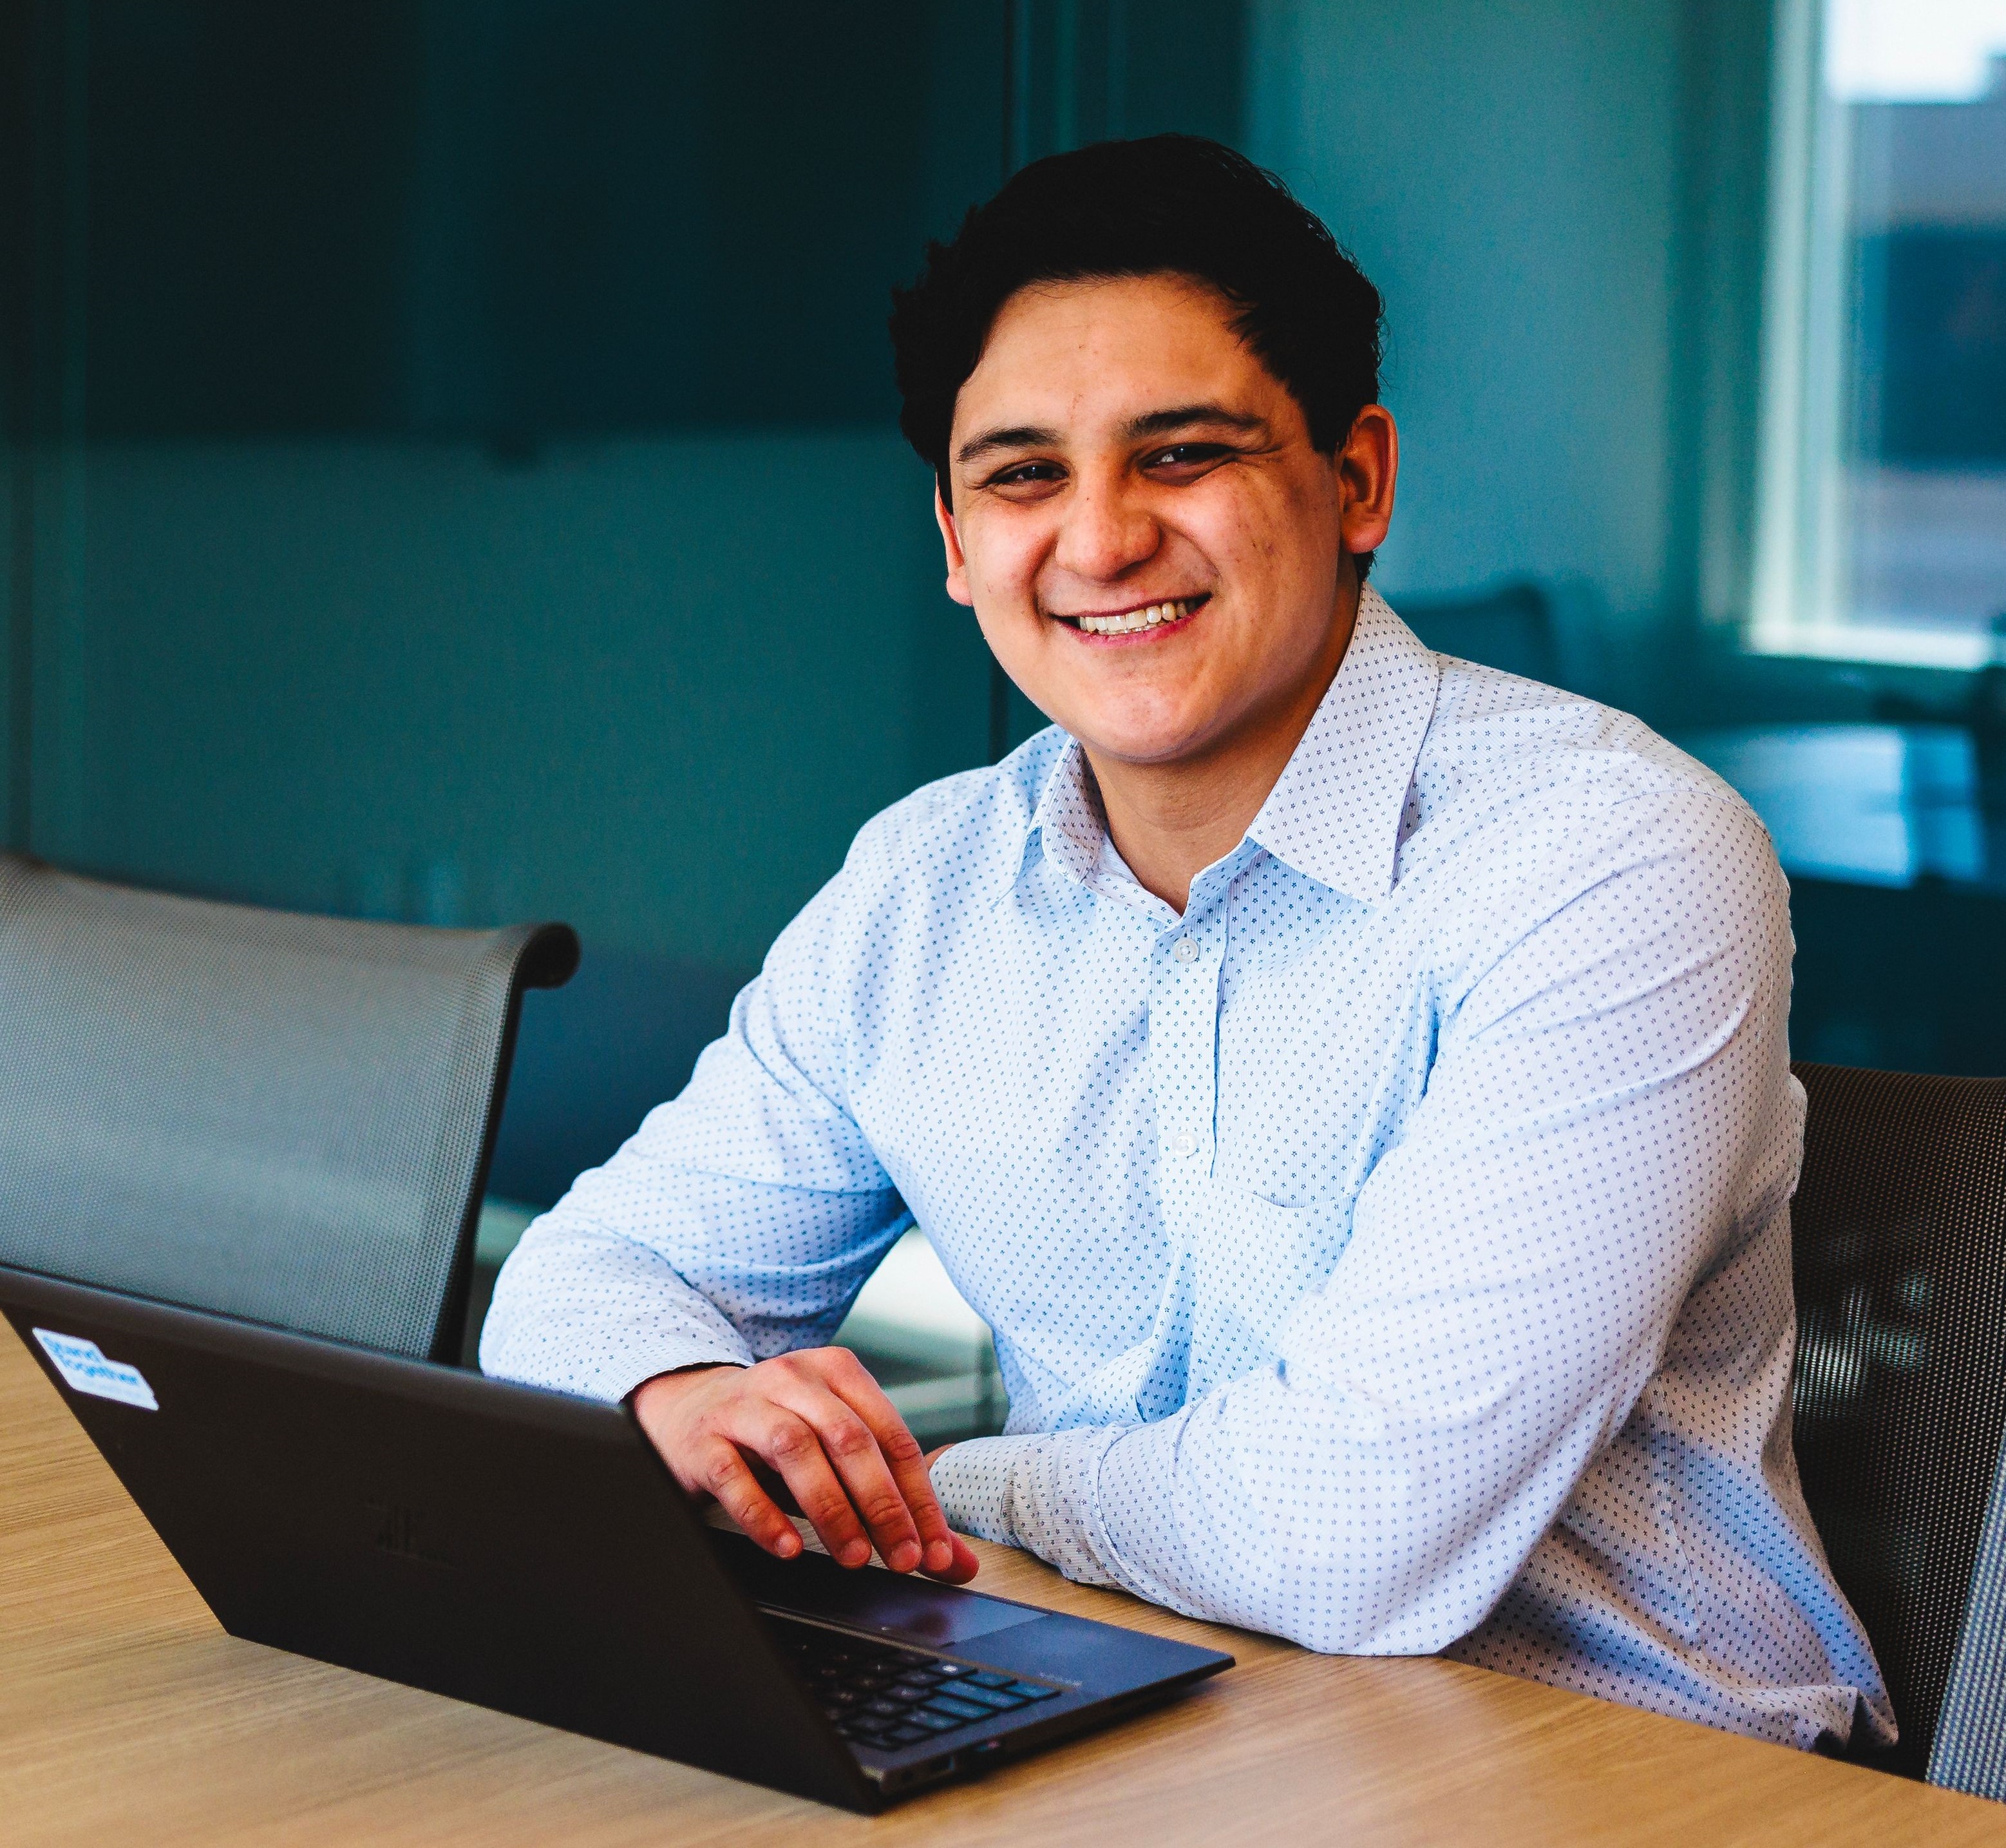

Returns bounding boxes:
[0,1330,2006,1848]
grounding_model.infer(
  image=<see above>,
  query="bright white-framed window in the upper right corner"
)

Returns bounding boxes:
[1749,0,2006,668]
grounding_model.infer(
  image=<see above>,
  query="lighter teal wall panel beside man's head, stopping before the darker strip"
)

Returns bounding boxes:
[1252,0,1679,610]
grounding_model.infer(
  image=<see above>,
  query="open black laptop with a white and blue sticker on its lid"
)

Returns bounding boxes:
[0,1266,1232,1810]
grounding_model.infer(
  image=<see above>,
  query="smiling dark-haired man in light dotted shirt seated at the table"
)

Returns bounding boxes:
[482,137,1891,1746]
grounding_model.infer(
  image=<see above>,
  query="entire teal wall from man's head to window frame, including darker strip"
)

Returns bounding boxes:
[1245,0,1767,710]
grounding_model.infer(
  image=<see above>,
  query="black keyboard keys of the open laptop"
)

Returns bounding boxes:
[766,1615,1065,1751]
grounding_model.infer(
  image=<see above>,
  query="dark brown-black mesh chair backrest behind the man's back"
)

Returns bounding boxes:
[1792,1065,2006,1778]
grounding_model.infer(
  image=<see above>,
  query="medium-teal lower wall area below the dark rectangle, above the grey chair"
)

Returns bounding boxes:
[50,430,989,965]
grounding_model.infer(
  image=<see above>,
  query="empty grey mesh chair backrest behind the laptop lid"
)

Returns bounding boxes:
[0,855,578,1360]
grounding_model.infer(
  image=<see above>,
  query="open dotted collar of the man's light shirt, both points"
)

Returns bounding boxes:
[999,584,1443,905]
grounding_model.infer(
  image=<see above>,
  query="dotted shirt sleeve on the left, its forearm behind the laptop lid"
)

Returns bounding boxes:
[482,869,909,1400]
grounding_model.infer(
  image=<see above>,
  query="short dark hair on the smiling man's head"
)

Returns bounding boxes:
[891,135,1382,578]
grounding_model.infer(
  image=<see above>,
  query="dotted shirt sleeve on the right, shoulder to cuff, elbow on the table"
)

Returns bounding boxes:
[932,797,1801,1653]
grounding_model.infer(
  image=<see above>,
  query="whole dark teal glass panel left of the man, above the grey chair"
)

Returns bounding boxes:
[8,0,1003,979]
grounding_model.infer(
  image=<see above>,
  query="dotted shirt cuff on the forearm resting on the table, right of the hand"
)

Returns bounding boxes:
[932,1425,1128,1585]
